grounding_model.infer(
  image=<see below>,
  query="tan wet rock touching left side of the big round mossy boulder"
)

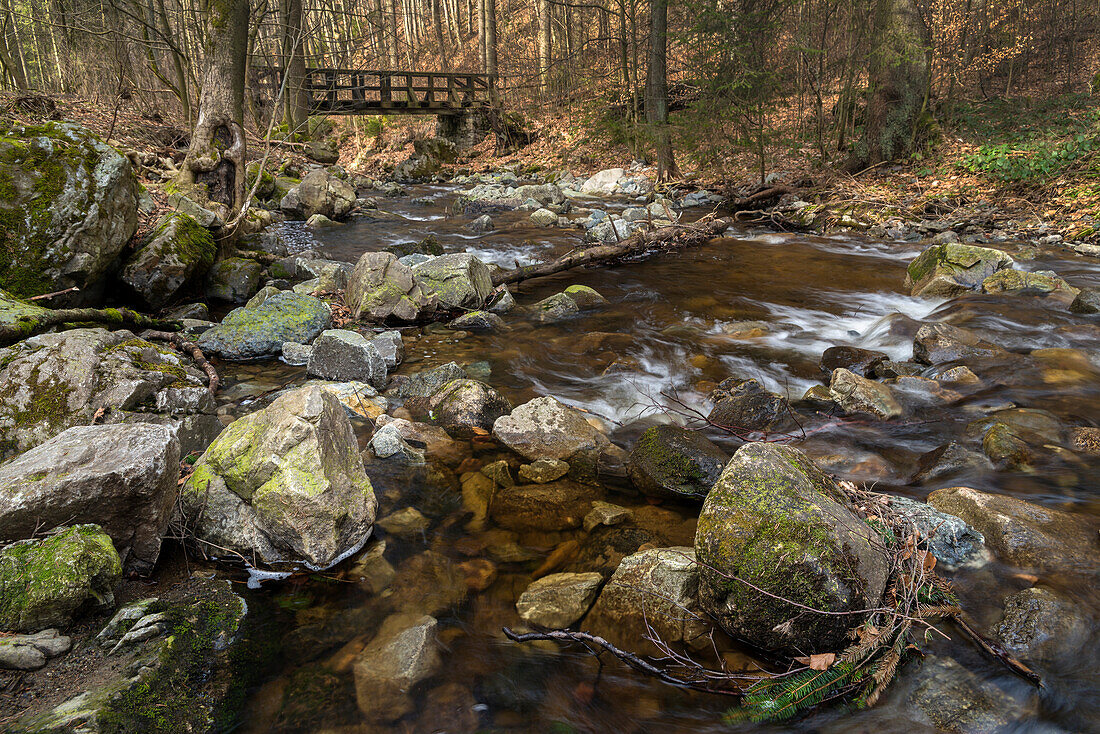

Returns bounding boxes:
[582,546,710,654]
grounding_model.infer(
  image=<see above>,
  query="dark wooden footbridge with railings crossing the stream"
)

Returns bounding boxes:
[261,68,496,114]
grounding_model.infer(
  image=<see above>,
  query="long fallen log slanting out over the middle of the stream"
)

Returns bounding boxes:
[493,217,734,285]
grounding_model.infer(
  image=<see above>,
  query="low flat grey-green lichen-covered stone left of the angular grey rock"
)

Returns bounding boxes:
[197,291,332,360]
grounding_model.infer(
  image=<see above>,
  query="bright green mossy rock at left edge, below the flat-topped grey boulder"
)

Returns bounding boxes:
[0,525,122,632]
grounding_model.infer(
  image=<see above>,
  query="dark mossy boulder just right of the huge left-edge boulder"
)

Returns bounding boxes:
[120,213,218,309]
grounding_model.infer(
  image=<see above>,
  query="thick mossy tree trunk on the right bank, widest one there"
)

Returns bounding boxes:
[849,0,931,171]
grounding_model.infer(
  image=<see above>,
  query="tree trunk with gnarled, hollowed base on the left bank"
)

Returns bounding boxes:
[180,0,249,225]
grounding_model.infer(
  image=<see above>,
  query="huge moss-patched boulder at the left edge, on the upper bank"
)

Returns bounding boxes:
[0,122,139,306]
